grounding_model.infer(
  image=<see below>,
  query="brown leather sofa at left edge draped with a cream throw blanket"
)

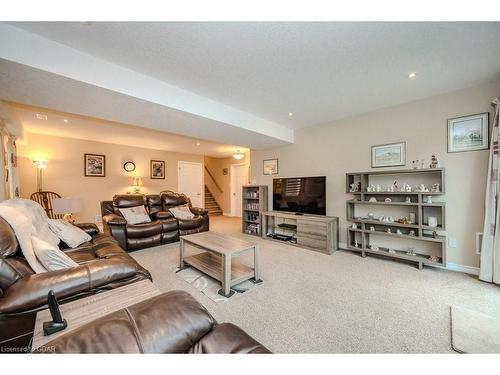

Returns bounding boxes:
[0,218,151,349]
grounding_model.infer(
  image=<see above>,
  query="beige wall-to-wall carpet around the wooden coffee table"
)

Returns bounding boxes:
[131,217,500,353]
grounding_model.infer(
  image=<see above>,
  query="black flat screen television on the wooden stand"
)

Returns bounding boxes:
[273,176,326,215]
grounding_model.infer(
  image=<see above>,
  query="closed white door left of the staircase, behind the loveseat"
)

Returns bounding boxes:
[177,161,205,207]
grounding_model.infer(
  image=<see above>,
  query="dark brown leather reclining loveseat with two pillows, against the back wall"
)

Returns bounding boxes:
[101,191,209,251]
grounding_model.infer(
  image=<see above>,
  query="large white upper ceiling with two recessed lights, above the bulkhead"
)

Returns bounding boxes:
[7,22,500,128]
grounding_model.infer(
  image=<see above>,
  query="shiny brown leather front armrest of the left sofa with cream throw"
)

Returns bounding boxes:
[0,257,138,314]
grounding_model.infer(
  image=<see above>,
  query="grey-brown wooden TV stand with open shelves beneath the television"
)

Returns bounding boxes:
[262,211,339,254]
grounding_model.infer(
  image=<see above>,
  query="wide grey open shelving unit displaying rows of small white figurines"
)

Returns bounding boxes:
[346,168,446,269]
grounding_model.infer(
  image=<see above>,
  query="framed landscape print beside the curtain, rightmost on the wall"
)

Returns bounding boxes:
[448,112,490,152]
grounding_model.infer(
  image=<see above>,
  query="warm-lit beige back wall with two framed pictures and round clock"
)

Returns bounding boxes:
[18,133,203,222]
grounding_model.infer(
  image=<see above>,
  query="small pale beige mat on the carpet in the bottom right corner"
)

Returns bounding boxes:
[450,306,500,354]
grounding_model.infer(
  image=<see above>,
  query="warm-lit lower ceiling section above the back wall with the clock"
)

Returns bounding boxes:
[6,103,248,158]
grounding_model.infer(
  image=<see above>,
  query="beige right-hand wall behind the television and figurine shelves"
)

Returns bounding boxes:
[251,81,500,267]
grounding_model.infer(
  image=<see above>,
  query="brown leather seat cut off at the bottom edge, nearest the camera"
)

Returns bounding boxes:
[37,291,270,353]
